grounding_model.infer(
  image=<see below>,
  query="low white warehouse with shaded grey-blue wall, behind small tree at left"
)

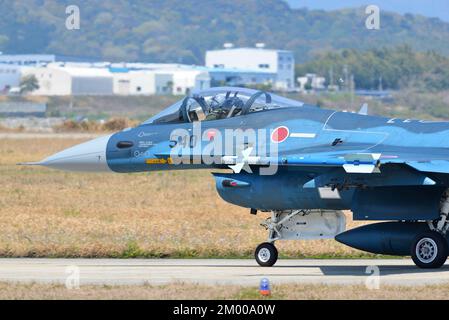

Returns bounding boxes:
[22,64,113,96]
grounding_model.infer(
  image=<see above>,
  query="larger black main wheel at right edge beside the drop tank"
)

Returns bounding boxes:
[410,231,449,269]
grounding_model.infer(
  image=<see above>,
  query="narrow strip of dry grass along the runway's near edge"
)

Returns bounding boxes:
[0,283,449,300]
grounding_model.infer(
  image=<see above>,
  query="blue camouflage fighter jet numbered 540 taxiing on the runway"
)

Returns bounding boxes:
[23,87,449,268]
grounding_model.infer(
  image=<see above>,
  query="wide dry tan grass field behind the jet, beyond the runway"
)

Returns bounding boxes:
[0,138,373,258]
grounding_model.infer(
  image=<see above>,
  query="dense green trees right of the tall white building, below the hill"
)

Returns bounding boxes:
[296,45,449,91]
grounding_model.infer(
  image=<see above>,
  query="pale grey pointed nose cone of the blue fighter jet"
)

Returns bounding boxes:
[39,135,112,172]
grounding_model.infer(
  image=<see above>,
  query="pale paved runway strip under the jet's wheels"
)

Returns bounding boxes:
[0,259,449,286]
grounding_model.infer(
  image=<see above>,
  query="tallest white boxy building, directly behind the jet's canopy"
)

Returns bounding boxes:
[206,44,295,91]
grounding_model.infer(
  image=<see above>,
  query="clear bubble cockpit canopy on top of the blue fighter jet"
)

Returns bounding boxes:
[144,87,303,124]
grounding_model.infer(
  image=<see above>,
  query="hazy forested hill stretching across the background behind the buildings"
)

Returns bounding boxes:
[0,0,449,64]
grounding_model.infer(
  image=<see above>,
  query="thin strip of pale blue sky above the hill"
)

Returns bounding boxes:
[286,0,449,22]
